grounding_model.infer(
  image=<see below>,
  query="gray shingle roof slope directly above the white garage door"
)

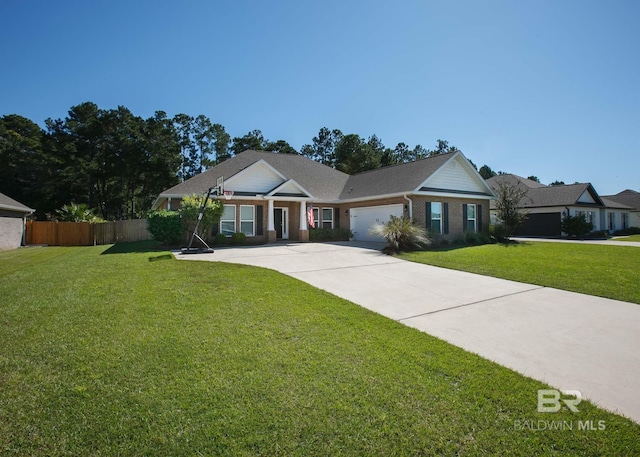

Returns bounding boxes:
[340,152,455,200]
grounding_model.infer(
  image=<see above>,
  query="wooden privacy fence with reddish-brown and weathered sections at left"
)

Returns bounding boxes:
[26,219,152,246]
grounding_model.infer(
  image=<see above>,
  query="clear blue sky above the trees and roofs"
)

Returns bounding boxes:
[0,0,640,195]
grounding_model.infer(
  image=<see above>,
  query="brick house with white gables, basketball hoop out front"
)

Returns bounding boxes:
[153,150,495,243]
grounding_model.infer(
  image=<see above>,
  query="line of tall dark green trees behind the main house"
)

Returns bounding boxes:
[0,102,536,220]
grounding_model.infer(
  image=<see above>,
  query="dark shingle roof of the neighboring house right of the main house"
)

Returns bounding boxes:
[487,174,605,208]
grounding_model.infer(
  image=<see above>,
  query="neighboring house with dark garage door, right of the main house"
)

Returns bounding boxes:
[487,174,631,236]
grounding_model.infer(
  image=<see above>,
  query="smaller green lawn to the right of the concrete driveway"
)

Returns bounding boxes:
[400,242,640,303]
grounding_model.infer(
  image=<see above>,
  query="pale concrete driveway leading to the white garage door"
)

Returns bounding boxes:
[176,242,640,422]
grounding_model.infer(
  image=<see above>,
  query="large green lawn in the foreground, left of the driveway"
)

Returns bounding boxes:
[0,244,640,456]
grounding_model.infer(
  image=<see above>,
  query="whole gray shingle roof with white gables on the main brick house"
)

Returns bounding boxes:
[154,150,495,207]
